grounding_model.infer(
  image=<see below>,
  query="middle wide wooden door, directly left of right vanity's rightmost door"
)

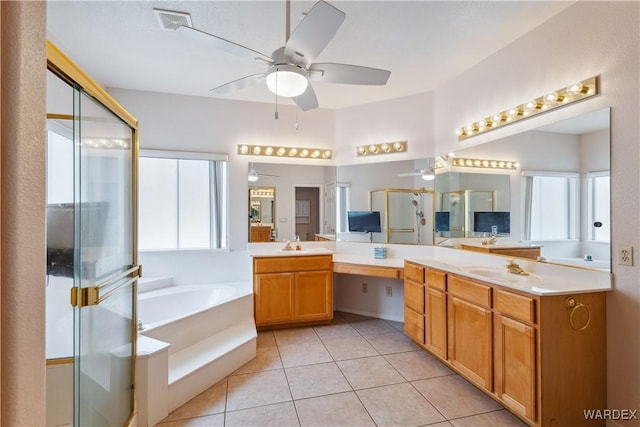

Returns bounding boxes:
[448,295,493,391]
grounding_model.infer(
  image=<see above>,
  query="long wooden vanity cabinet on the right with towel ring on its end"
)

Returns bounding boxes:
[405,261,606,427]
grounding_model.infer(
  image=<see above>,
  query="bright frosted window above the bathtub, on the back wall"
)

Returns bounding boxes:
[138,150,228,250]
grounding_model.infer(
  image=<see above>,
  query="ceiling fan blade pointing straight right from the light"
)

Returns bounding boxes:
[309,63,391,86]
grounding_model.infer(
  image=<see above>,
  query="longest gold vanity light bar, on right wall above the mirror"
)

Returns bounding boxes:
[456,77,598,141]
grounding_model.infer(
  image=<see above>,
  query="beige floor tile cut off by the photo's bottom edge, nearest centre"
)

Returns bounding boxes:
[295,392,375,427]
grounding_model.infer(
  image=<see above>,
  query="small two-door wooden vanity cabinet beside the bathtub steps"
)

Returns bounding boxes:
[253,255,333,328]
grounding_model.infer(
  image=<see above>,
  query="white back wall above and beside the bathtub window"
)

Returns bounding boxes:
[109,89,335,250]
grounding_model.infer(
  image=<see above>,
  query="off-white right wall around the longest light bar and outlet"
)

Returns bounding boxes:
[435,2,640,418]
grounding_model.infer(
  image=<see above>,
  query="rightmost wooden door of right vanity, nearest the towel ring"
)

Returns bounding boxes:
[494,315,536,421]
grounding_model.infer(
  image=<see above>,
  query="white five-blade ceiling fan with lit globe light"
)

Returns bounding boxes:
[170,0,391,111]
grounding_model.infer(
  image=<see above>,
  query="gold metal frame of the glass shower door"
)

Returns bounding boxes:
[46,40,142,425]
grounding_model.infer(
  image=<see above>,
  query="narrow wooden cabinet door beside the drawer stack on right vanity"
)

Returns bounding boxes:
[425,287,447,359]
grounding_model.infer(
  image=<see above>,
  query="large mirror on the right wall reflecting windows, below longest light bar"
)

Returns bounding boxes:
[434,108,611,270]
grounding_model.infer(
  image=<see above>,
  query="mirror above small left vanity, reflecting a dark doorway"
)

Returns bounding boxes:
[247,163,336,242]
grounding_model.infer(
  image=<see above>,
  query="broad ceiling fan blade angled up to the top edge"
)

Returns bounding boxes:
[284,0,346,67]
